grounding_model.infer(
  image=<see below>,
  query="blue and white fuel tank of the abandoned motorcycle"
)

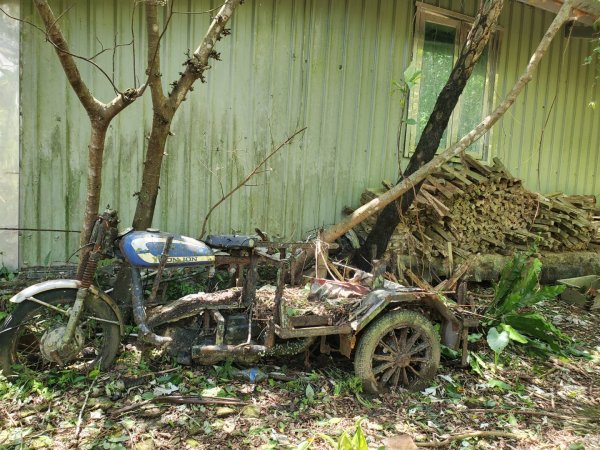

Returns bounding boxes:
[119,231,215,267]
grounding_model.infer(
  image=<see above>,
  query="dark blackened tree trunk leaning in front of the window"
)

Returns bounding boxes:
[355,0,504,268]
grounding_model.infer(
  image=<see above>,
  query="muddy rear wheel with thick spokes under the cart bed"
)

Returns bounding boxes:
[354,311,440,393]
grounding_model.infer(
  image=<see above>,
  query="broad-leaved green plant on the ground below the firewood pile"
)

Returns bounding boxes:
[487,251,573,362]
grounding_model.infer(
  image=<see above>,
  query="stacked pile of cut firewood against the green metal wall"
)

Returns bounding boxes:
[355,155,600,258]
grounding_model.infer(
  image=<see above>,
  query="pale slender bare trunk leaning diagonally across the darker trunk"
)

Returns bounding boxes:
[322,0,571,248]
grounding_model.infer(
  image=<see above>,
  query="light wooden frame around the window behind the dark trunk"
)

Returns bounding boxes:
[404,2,502,161]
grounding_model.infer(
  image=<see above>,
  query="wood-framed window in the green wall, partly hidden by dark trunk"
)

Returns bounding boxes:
[405,2,498,159]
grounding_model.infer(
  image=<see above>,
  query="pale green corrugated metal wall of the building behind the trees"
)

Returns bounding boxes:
[21,0,600,265]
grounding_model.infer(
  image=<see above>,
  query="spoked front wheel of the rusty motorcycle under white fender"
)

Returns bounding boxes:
[0,289,120,375]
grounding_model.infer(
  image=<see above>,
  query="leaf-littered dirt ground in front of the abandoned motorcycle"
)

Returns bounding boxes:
[0,280,600,450]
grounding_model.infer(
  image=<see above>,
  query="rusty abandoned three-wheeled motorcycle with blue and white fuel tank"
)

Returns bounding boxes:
[0,209,466,391]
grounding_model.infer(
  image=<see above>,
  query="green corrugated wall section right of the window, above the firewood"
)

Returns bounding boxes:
[492,2,600,195]
